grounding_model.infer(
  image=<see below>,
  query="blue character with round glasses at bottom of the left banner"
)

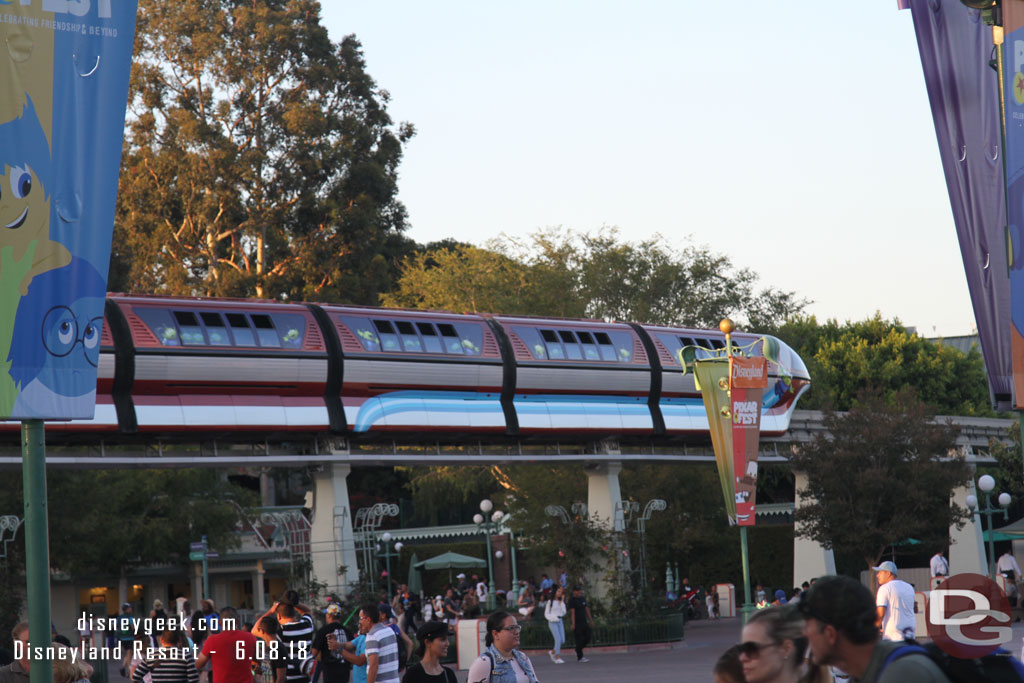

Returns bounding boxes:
[10,259,105,419]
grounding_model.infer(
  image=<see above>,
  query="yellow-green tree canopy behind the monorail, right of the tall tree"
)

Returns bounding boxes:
[381,228,807,329]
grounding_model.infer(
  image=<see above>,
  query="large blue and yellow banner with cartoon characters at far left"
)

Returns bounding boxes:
[0,0,137,420]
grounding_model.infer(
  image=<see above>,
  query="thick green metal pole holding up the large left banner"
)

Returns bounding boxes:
[22,420,53,683]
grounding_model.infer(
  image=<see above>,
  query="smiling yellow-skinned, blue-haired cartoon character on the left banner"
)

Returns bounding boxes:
[0,98,71,417]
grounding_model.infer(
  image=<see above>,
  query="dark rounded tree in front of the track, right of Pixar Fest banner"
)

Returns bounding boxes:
[790,390,970,567]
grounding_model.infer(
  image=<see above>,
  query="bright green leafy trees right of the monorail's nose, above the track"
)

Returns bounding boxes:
[775,313,992,415]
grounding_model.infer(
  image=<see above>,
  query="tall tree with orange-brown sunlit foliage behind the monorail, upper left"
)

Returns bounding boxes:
[111,0,414,303]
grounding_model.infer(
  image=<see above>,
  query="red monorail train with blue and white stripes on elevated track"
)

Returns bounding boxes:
[0,294,810,440]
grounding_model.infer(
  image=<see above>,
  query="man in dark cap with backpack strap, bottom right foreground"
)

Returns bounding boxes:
[797,577,949,683]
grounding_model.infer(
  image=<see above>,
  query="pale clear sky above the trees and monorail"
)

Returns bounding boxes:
[323,0,975,336]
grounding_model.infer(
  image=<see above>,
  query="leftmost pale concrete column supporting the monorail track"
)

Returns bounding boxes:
[311,463,359,594]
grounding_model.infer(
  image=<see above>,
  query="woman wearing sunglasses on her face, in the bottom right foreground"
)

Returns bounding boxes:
[739,606,826,683]
